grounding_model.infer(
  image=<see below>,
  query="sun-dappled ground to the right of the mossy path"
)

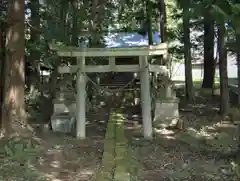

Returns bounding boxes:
[131,97,240,181]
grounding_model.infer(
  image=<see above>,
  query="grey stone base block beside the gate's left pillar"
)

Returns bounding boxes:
[51,114,76,133]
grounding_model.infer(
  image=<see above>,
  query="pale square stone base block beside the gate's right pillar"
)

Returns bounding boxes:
[153,99,179,127]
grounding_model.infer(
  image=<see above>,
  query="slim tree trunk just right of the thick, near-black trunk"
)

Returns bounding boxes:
[218,21,229,115]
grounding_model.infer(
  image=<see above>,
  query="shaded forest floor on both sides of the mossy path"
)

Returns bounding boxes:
[0,93,240,181]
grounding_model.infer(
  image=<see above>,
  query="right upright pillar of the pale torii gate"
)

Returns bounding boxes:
[139,56,152,139]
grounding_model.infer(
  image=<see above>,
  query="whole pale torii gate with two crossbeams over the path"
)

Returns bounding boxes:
[49,43,168,139]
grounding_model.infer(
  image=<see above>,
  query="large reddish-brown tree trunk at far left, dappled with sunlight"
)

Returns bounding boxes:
[2,0,27,133]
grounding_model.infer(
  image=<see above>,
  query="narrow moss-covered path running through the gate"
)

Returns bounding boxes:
[96,110,130,181]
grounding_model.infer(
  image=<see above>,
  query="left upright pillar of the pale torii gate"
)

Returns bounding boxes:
[76,57,86,139]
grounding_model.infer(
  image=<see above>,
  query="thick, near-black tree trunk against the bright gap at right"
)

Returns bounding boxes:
[202,9,216,89]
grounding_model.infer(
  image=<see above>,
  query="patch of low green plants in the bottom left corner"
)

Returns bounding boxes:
[0,137,44,181]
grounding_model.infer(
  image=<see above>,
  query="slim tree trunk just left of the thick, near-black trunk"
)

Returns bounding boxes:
[183,0,194,102]
